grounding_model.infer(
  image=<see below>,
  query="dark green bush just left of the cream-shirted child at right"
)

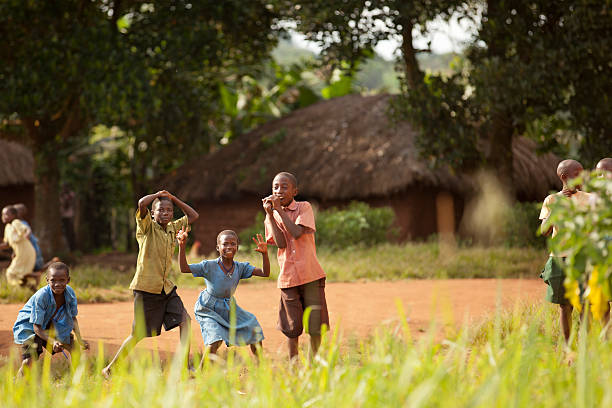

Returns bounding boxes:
[504,202,546,248]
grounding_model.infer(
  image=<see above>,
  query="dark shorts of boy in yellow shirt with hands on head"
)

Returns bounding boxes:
[132,286,190,337]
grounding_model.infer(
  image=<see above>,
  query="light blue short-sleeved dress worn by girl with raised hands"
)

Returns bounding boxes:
[189,259,264,346]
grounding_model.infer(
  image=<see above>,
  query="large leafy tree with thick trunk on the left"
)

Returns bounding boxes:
[0,0,276,252]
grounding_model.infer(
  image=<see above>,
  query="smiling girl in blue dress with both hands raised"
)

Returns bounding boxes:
[176,229,270,356]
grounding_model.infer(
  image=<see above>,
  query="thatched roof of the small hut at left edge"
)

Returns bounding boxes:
[0,139,34,186]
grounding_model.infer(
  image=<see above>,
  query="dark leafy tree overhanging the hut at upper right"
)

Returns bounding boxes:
[400,0,612,188]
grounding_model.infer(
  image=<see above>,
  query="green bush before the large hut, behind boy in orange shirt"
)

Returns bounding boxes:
[239,201,398,249]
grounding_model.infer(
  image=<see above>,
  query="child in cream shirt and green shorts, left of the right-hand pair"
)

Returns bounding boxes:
[540,160,593,341]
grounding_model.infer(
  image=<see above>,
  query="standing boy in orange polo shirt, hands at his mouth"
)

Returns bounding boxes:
[262,172,329,358]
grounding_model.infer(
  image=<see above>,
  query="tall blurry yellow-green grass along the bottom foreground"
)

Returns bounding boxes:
[0,305,612,408]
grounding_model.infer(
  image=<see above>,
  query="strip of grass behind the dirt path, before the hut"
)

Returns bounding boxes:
[0,243,547,303]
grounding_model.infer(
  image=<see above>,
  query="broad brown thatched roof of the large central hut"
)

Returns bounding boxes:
[161,95,559,201]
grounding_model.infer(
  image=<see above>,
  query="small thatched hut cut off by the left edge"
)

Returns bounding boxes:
[0,139,34,236]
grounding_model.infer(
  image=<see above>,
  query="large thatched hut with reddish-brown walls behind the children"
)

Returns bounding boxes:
[160,94,559,250]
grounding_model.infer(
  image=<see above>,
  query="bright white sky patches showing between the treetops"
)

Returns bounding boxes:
[291,12,477,60]
